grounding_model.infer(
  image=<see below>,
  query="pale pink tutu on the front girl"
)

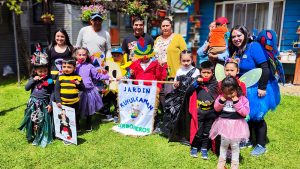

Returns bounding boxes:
[209,117,249,141]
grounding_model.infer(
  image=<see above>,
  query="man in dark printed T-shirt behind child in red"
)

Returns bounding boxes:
[122,16,154,60]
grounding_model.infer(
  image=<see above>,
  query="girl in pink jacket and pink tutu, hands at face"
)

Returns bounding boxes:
[209,76,250,169]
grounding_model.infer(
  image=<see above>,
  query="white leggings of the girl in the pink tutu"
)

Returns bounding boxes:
[219,136,240,162]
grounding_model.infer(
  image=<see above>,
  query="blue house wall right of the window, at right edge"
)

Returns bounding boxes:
[280,0,300,50]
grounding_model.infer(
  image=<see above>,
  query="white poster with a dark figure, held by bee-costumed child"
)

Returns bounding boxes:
[52,102,77,145]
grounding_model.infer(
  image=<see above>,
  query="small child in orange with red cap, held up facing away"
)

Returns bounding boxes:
[208,17,229,64]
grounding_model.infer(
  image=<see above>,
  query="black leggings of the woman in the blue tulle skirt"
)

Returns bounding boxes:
[248,120,267,147]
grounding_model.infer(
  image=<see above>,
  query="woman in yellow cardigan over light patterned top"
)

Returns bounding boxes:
[154,18,187,78]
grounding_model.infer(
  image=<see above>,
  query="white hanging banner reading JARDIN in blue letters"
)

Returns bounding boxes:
[113,81,157,136]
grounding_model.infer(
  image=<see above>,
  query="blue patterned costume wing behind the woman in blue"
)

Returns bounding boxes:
[255,30,285,84]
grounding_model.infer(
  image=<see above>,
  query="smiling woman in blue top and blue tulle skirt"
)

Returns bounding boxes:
[229,25,280,156]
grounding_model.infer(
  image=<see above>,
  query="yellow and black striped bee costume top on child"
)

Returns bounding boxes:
[55,74,84,105]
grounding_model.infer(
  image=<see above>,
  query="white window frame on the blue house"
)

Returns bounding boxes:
[214,0,286,50]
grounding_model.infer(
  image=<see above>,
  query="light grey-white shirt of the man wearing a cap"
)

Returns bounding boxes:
[76,26,111,58]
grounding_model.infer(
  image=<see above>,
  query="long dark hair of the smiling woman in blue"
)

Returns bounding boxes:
[228,25,250,56]
